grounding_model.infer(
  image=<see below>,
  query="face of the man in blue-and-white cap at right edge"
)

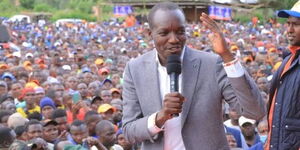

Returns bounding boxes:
[287,17,300,46]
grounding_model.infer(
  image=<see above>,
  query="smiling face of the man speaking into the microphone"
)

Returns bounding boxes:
[150,10,186,62]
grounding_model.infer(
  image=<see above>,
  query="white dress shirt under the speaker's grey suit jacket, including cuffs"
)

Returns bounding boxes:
[148,48,244,150]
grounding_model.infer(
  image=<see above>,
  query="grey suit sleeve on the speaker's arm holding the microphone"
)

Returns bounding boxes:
[122,62,154,143]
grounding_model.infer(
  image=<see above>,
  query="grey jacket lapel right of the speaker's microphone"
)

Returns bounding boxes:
[181,47,200,127]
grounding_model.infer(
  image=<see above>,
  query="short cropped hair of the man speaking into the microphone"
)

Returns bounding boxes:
[147,2,183,29]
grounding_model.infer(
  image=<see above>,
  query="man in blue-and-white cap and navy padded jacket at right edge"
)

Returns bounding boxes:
[266,1,300,150]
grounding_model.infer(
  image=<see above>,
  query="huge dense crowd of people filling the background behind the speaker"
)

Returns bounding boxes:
[0,8,288,150]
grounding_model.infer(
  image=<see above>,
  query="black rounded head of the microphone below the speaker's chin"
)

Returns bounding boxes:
[167,54,181,74]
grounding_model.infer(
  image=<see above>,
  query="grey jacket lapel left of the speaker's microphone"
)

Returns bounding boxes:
[144,50,162,112]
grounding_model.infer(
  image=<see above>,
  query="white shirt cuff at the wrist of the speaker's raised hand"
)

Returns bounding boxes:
[223,59,245,78]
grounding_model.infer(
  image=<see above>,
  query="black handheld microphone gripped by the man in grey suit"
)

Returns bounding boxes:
[167,54,181,117]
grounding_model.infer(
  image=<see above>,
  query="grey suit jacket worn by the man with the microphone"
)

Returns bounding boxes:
[123,48,266,150]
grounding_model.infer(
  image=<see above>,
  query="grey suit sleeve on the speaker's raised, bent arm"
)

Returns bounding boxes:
[216,59,266,120]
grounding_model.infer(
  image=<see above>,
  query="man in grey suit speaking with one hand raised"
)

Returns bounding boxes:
[123,2,265,150]
